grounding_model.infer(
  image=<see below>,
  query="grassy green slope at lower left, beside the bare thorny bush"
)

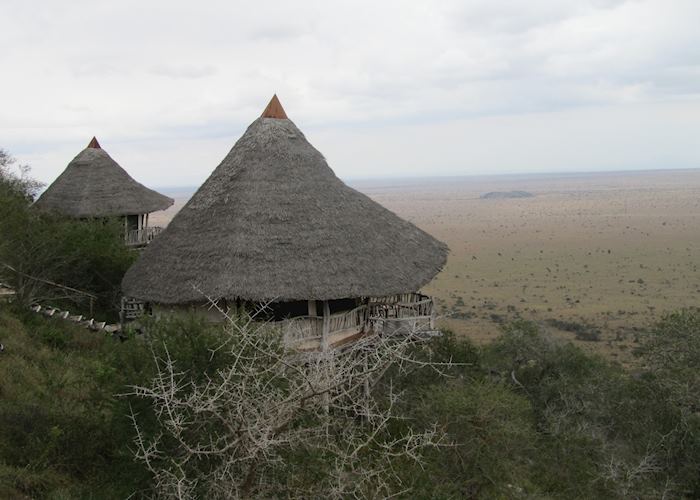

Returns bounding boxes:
[0,305,150,498]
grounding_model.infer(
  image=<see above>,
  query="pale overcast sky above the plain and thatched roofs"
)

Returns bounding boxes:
[0,0,700,187]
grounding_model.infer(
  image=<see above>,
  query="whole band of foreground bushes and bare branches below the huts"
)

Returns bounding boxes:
[0,306,700,499]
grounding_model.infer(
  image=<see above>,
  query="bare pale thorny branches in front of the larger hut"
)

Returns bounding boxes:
[128,300,450,498]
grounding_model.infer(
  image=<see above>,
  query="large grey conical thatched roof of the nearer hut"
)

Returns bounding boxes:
[122,97,447,304]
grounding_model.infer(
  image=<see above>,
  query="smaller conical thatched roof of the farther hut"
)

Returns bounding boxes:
[35,137,173,217]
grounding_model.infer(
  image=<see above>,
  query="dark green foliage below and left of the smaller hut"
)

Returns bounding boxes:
[0,146,136,319]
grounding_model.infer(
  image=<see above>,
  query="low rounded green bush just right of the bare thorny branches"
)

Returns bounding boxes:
[406,380,537,498]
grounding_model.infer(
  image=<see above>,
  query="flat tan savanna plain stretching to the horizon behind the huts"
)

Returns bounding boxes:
[153,170,700,365]
